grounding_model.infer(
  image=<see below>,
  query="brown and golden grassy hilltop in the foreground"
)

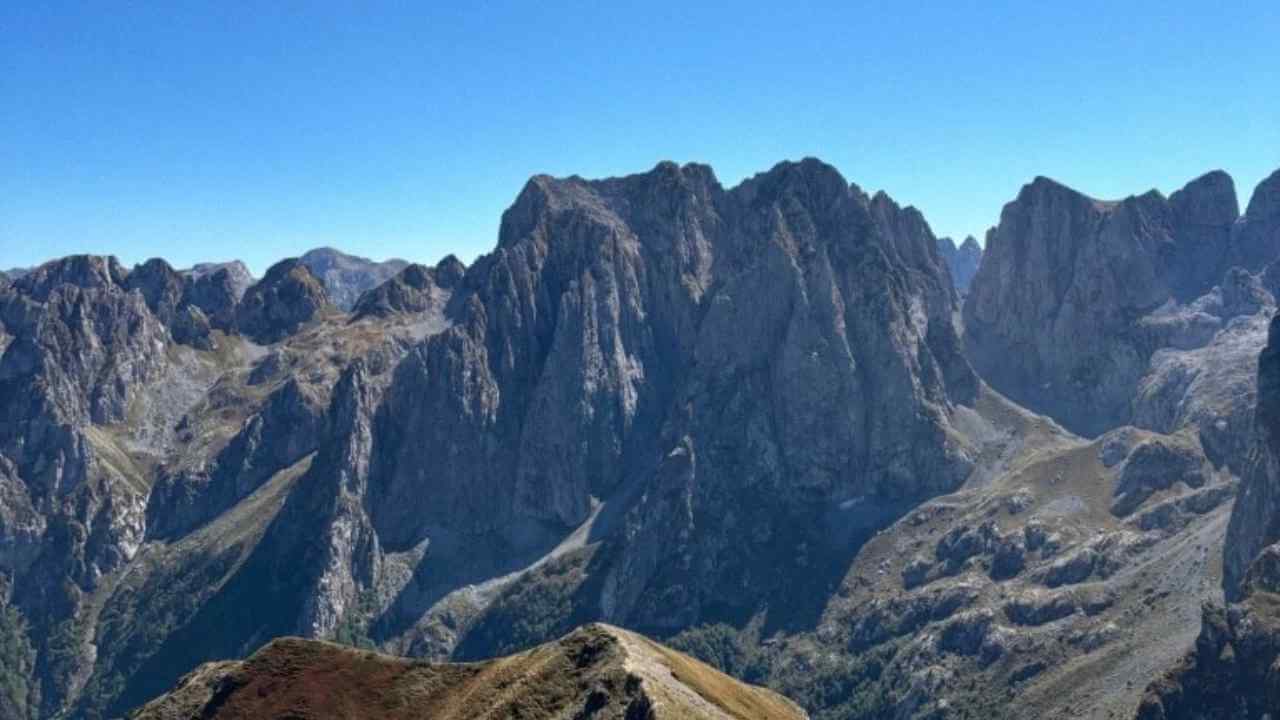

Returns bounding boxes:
[132,625,808,720]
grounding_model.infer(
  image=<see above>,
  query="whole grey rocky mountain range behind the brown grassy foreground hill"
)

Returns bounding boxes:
[0,160,1280,719]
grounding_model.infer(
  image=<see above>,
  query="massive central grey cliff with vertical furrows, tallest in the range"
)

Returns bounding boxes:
[285,160,977,635]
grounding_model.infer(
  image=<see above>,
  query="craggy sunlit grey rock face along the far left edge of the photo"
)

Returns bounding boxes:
[0,256,168,716]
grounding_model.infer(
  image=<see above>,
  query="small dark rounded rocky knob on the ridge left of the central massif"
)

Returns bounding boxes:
[236,259,332,343]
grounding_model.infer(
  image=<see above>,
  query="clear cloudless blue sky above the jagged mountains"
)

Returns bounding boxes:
[0,0,1280,272]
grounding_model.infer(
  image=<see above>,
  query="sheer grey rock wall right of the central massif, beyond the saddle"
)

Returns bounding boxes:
[964,172,1275,436]
